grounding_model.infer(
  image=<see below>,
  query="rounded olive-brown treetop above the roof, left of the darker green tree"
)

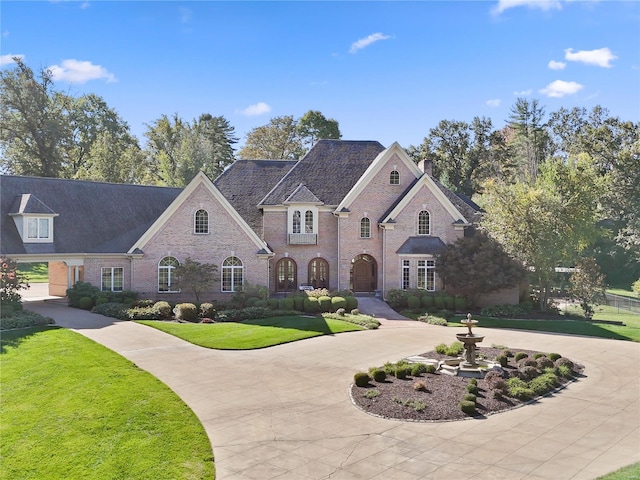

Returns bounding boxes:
[238,115,305,160]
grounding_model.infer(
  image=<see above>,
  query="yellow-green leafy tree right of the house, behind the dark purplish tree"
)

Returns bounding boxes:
[481,156,602,310]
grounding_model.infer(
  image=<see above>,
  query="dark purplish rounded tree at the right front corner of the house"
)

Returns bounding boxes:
[438,231,525,305]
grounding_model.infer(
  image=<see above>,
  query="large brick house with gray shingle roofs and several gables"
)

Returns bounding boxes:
[0,140,517,303]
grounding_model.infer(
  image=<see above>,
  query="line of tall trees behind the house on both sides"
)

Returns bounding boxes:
[0,59,640,292]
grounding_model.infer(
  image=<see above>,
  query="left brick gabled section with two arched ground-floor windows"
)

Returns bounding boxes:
[129,173,273,301]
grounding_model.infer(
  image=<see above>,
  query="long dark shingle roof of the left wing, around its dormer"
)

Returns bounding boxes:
[0,175,182,256]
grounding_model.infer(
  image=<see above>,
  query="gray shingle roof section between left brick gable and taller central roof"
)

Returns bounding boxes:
[213,160,297,234]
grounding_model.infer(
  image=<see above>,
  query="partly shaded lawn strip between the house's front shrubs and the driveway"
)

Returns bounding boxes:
[139,316,364,350]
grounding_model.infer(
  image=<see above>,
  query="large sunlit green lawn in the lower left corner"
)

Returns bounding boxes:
[0,327,214,480]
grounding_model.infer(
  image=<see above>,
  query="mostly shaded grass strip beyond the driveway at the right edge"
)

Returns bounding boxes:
[449,306,640,342]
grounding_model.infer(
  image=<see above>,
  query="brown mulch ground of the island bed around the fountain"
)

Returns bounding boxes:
[351,347,582,421]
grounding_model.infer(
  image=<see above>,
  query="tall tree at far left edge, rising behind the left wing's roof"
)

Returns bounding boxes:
[0,58,67,177]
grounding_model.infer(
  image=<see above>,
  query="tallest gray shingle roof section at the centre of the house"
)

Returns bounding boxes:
[260,140,384,205]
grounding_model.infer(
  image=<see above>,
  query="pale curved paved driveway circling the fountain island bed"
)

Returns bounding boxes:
[27,302,640,480]
